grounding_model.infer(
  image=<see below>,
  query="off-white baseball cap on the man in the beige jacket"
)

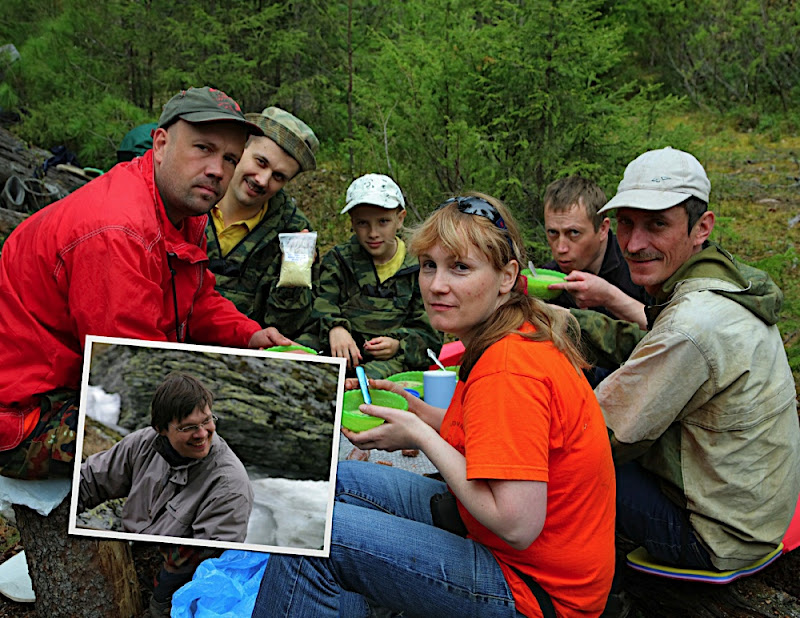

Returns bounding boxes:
[597,147,711,214]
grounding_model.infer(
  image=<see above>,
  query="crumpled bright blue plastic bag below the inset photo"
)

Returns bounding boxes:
[170,549,269,618]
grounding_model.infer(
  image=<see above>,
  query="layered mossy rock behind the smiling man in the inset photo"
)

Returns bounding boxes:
[89,345,339,480]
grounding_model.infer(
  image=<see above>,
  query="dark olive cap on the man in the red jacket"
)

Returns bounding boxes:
[158,86,264,135]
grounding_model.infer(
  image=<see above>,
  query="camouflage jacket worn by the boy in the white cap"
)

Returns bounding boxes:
[313,235,442,371]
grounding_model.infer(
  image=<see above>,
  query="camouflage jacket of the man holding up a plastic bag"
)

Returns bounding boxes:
[206,190,313,339]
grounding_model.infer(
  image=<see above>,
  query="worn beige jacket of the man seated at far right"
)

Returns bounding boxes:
[596,257,800,569]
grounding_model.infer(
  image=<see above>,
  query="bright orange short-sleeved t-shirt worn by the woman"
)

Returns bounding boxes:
[440,324,615,617]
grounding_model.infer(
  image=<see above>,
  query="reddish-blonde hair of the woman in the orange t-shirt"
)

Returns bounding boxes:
[408,193,588,381]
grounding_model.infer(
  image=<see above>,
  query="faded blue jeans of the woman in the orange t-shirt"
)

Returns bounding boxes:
[253,461,522,618]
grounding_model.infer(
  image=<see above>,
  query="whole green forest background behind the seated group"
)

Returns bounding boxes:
[0,0,800,378]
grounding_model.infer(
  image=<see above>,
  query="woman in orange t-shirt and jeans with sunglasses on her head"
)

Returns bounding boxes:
[253,194,614,618]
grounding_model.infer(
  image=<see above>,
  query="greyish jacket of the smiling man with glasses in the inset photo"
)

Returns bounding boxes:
[79,427,253,542]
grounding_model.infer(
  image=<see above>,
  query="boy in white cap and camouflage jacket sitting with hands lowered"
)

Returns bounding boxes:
[308,174,442,378]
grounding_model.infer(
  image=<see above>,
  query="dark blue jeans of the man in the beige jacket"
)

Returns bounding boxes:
[616,462,714,570]
